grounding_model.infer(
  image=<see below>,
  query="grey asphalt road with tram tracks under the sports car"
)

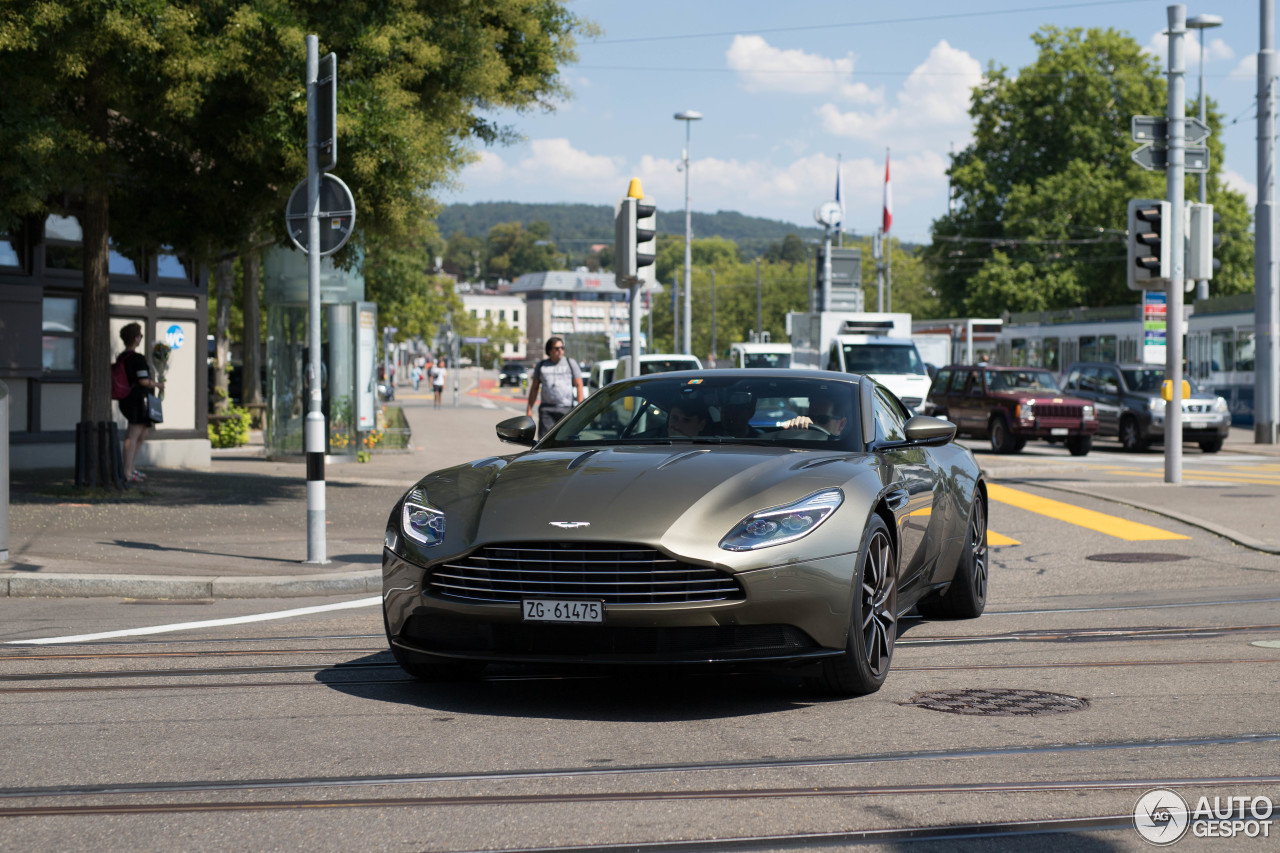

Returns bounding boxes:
[0,397,1280,850]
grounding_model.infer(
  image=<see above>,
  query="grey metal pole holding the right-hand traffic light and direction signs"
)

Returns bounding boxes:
[1165,3,1187,483]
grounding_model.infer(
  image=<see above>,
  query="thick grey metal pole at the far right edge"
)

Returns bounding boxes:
[1253,0,1280,444]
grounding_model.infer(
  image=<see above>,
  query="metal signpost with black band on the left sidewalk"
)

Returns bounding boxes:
[303,36,327,564]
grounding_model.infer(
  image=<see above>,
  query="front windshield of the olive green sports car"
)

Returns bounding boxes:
[539,371,863,451]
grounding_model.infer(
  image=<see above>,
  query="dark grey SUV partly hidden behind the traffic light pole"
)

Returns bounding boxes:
[1062,361,1231,453]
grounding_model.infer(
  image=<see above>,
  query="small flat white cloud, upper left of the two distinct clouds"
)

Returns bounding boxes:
[724,36,884,104]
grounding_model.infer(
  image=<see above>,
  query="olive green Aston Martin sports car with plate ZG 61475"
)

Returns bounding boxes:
[383,369,987,695]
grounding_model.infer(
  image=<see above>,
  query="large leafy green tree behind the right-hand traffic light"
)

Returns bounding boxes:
[926,27,1252,316]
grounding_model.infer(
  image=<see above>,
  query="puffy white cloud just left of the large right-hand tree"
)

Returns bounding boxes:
[818,40,982,147]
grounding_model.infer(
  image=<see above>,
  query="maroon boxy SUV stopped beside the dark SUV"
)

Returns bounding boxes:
[925,364,1098,456]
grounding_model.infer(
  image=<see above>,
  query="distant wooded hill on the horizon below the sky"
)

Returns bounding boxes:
[438,201,822,257]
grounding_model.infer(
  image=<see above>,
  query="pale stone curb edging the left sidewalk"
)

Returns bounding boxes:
[0,569,383,599]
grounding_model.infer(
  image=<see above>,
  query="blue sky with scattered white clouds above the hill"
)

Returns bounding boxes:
[440,0,1274,242]
